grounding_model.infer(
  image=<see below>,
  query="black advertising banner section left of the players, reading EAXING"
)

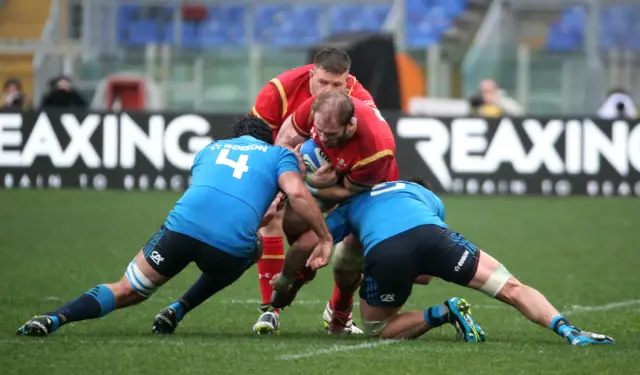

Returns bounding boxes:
[0,112,235,191]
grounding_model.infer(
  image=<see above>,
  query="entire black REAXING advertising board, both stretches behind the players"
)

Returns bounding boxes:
[0,111,640,196]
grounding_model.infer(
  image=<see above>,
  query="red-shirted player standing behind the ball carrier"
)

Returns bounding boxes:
[251,48,375,333]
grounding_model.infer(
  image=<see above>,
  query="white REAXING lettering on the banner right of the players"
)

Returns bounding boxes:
[397,118,640,195]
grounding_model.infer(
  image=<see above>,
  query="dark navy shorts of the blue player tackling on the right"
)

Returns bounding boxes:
[360,225,478,307]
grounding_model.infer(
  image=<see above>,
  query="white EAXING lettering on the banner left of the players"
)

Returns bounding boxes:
[0,112,212,170]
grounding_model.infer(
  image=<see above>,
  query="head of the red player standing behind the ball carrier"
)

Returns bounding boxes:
[309,48,351,95]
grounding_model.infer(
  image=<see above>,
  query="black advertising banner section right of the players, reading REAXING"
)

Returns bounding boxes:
[389,117,640,196]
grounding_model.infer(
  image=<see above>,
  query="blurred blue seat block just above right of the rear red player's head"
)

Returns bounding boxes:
[329,5,391,34]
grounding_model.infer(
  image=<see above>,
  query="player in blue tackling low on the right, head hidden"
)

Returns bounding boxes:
[273,180,615,345]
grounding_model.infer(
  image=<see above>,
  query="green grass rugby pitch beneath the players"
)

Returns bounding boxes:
[0,191,640,375]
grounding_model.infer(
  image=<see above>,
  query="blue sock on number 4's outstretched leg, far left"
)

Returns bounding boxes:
[46,285,116,329]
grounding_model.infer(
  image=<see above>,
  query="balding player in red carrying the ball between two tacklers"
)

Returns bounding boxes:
[276,91,398,333]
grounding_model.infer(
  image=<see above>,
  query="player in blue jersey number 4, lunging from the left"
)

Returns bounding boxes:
[17,117,333,336]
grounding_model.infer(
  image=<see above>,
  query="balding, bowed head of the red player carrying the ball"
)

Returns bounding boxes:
[313,91,358,148]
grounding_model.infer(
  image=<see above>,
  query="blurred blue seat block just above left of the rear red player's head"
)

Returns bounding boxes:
[254,5,322,47]
